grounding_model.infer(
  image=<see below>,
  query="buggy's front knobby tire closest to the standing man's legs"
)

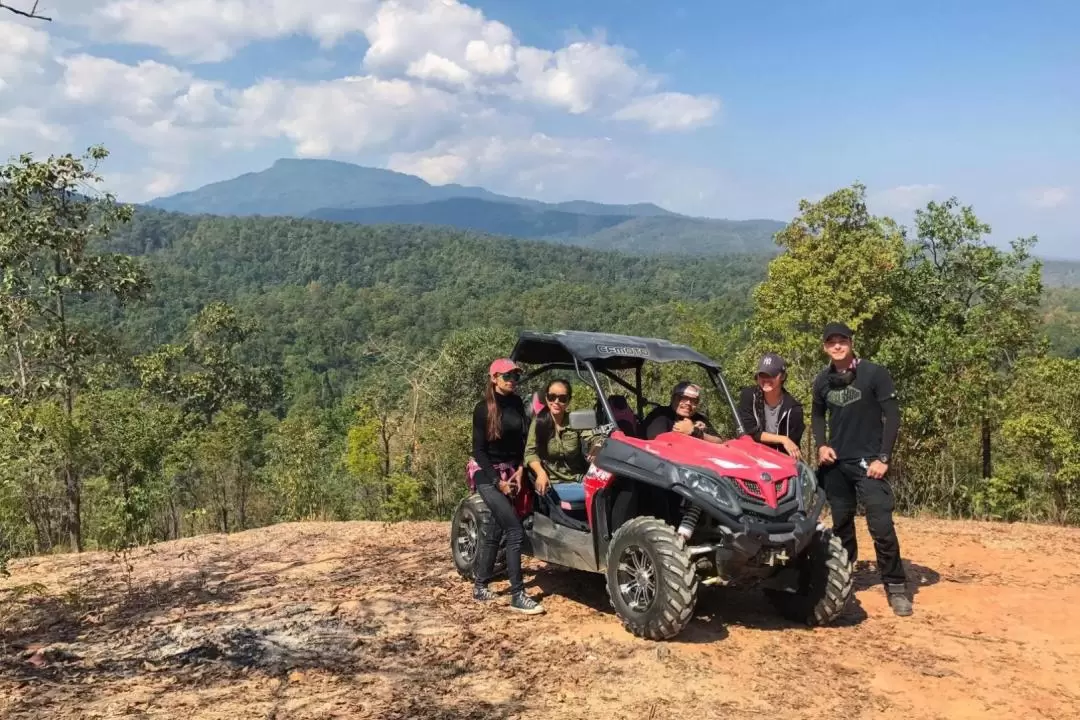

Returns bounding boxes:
[767,530,852,627]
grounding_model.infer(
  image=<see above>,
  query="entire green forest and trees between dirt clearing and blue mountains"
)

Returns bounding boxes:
[0,150,1080,565]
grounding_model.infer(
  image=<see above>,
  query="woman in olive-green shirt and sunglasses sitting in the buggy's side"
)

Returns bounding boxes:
[525,379,602,494]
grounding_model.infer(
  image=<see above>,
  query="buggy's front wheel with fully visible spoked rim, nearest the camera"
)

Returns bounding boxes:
[606,517,698,640]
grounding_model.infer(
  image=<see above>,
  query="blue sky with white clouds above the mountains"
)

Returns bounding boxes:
[0,0,1080,258]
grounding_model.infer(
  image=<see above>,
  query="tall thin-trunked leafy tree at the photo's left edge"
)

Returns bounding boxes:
[0,147,148,551]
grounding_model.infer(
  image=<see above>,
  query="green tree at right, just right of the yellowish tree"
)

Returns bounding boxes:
[882,198,1042,490]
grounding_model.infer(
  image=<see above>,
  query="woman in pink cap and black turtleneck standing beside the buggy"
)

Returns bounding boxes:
[470,357,543,615]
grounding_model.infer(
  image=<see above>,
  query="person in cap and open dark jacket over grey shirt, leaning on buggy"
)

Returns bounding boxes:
[739,353,806,458]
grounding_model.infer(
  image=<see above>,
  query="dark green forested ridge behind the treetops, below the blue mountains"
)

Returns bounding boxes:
[98,210,766,362]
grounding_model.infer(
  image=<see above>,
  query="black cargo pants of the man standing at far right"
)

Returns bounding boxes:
[819,460,907,585]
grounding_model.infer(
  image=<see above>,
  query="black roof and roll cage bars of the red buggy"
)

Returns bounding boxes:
[510,330,746,436]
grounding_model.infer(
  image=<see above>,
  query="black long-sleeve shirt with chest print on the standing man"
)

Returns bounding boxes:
[811,361,900,460]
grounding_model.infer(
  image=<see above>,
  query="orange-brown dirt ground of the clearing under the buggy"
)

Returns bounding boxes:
[0,519,1080,720]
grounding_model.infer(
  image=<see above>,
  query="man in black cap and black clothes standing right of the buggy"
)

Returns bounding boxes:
[811,323,912,615]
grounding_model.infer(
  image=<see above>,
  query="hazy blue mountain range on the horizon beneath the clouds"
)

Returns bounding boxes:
[148,159,784,256]
